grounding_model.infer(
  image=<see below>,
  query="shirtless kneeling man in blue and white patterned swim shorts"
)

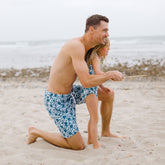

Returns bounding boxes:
[27,15,123,150]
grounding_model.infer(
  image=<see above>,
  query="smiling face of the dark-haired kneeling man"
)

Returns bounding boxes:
[94,21,109,44]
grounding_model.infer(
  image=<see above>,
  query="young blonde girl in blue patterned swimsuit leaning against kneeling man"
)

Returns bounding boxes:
[85,39,110,149]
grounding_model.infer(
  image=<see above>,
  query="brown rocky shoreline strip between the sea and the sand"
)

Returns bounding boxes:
[0,59,165,81]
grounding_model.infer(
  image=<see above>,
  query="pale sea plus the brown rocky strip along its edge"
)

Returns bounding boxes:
[0,36,165,80]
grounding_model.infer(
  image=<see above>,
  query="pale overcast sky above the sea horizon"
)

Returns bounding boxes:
[0,0,165,41]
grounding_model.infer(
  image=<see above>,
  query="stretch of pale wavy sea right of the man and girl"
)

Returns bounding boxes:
[105,36,165,66]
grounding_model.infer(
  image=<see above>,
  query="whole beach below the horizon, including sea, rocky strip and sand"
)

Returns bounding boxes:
[0,36,165,165]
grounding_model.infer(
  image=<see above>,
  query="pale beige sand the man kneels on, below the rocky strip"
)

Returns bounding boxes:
[0,79,165,165]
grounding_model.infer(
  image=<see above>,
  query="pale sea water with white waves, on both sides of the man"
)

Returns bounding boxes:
[0,36,165,69]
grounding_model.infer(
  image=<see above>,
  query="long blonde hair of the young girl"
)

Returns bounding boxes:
[85,38,110,65]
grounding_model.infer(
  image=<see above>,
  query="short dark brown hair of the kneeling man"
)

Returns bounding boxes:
[85,14,109,32]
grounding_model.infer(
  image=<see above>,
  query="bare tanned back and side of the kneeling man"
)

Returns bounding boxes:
[48,38,84,94]
